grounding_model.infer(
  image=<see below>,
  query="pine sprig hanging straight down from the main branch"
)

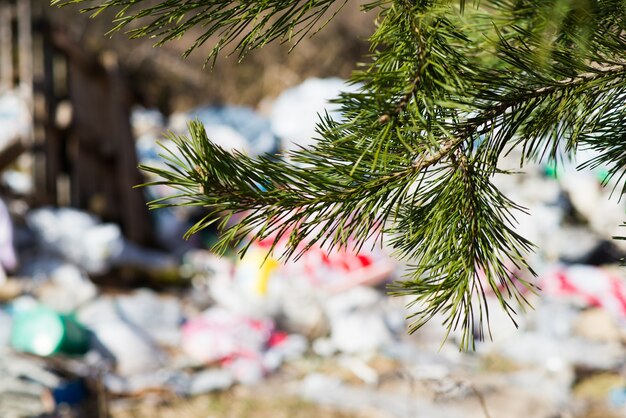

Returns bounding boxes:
[392,156,532,348]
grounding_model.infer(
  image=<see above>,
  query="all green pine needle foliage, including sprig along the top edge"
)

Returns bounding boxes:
[53,0,626,348]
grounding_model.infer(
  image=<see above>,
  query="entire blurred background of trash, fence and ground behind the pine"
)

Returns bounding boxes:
[0,0,626,418]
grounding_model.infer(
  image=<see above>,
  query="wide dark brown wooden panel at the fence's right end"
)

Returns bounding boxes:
[52,30,154,245]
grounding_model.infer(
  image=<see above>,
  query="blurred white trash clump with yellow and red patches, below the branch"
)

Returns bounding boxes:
[207,230,397,338]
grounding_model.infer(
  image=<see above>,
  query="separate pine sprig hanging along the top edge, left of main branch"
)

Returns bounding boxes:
[52,0,347,62]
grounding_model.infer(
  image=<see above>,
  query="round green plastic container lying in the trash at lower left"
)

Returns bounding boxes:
[11,306,89,356]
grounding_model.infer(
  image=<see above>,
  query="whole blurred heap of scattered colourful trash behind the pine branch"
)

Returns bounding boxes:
[0,79,626,418]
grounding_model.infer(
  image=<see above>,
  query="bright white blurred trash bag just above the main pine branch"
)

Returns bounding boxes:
[270,78,357,151]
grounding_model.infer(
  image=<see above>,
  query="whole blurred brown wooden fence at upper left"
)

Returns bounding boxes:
[0,0,154,244]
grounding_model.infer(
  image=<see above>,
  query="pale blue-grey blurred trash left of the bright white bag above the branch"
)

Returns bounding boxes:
[169,106,278,157]
